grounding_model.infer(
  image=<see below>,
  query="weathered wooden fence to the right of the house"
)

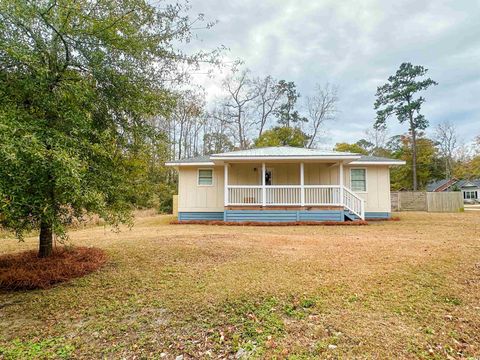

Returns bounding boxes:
[391,191,463,212]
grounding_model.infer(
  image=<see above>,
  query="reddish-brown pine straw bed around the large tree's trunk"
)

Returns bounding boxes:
[0,247,107,290]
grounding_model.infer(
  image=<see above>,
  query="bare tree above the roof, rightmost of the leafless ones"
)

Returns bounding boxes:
[306,83,338,148]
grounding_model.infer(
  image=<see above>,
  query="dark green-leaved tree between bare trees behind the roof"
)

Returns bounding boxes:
[275,80,308,127]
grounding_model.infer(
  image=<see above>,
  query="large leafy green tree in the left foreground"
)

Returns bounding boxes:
[0,0,213,257]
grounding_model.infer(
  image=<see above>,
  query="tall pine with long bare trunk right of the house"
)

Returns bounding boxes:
[374,63,437,190]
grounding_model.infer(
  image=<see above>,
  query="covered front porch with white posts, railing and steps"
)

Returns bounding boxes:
[224,161,365,219]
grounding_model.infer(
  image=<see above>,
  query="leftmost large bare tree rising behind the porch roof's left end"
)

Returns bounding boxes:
[222,69,258,149]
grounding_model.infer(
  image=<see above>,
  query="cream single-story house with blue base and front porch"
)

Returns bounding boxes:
[166,146,405,222]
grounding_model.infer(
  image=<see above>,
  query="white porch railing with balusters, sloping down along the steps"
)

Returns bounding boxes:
[225,185,365,219]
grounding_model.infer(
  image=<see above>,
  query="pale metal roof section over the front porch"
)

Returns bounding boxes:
[212,146,359,158]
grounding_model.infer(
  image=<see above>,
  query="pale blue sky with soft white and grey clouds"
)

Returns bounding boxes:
[185,0,480,145]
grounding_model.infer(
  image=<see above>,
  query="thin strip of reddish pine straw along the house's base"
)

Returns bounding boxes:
[170,220,368,226]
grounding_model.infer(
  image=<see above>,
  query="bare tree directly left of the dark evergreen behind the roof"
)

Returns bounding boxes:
[252,75,282,137]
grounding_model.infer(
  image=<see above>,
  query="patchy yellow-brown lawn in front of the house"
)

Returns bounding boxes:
[0,211,480,359]
